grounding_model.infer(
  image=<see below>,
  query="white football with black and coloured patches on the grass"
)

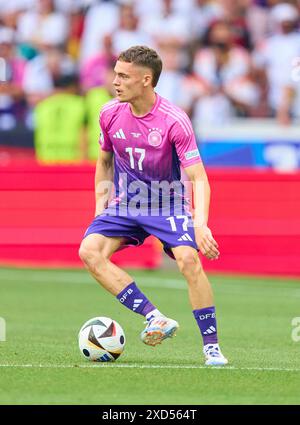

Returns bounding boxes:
[78,317,126,362]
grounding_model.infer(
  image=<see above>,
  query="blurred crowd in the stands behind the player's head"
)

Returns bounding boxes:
[0,0,300,136]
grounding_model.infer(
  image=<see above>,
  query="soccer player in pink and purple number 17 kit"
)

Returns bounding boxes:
[79,46,228,366]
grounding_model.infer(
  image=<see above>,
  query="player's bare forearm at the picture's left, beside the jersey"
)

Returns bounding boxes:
[95,147,113,216]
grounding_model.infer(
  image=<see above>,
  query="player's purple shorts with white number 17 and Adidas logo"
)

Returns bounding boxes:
[84,208,198,259]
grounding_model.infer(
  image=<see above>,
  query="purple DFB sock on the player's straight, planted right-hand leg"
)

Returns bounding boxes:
[193,306,218,345]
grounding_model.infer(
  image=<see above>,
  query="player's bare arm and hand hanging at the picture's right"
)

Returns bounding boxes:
[184,162,220,260]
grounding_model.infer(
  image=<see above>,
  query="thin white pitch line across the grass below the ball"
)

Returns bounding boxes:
[0,363,300,372]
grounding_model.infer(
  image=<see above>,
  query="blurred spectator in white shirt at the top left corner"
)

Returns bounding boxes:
[17,0,69,59]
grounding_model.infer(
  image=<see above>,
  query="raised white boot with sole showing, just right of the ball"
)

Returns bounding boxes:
[141,316,179,346]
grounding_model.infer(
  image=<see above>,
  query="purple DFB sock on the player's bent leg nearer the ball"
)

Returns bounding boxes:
[117,282,155,316]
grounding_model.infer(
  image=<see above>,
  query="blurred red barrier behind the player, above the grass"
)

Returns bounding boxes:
[0,163,300,276]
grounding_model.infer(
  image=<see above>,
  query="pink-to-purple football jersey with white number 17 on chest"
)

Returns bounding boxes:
[100,94,201,210]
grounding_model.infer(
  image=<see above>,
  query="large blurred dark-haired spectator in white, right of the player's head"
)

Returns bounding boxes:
[192,21,259,124]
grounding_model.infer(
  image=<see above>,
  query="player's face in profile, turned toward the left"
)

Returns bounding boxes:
[113,61,152,103]
